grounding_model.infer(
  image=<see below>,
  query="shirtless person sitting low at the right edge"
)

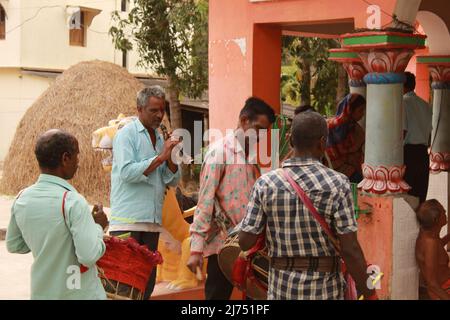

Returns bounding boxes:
[416,199,450,300]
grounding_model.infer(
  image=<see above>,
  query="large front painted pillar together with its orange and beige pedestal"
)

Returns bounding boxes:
[342,32,425,299]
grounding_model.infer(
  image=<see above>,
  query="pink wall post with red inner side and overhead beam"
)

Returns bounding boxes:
[209,0,395,131]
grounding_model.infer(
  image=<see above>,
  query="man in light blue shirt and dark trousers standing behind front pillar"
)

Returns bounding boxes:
[403,72,433,203]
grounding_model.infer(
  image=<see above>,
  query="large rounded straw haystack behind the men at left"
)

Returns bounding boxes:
[0,61,143,205]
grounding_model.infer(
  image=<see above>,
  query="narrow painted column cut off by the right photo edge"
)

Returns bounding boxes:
[417,55,450,174]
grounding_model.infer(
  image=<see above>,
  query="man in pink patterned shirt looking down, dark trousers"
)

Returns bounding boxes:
[187,97,275,300]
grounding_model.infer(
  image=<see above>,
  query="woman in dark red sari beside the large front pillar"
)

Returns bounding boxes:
[326,94,366,183]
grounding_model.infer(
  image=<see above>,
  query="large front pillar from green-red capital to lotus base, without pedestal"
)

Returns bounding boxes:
[342,32,426,194]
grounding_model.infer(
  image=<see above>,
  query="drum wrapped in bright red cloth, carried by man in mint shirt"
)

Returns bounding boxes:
[97,237,162,300]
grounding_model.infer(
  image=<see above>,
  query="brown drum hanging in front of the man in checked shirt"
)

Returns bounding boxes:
[218,233,269,300]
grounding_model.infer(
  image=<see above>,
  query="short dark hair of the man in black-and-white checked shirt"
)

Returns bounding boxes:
[291,111,328,150]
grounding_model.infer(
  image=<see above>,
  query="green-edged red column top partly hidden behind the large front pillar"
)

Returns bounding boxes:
[329,49,367,97]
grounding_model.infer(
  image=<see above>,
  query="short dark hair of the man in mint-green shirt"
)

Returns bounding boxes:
[34,130,78,169]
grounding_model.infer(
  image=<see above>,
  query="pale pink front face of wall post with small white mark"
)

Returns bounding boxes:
[209,0,253,133]
